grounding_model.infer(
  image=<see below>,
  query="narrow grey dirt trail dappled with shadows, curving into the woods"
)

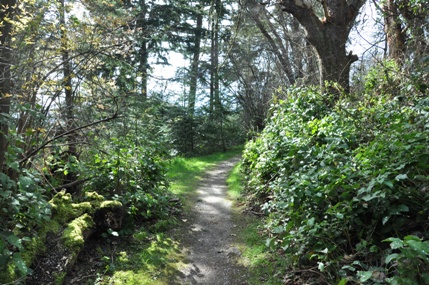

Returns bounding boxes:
[174,157,247,285]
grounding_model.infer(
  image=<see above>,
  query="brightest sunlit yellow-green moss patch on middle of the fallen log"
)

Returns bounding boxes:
[61,214,94,250]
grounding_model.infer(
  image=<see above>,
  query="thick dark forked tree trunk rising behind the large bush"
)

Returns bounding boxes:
[281,0,365,92]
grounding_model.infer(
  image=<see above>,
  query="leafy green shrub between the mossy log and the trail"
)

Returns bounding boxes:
[83,137,169,220]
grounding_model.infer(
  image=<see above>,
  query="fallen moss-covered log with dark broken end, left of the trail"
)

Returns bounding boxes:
[26,191,124,285]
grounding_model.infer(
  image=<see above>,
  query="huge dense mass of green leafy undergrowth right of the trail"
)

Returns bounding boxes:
[243,61,429,284]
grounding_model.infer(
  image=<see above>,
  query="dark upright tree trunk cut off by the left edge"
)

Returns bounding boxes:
[0,0,16,172]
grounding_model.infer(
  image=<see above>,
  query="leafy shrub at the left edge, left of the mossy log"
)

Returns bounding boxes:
[0,131,51,282]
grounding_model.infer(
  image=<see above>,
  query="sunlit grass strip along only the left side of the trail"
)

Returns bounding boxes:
[64,149,241,285]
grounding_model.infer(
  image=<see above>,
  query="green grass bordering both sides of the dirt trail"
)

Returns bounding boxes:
[65,149,281,285]
